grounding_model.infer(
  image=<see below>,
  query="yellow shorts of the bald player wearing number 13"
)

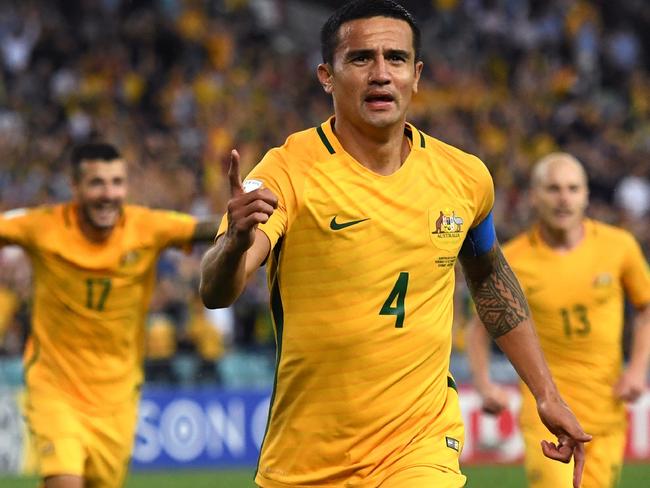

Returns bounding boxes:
[521,423,625,488]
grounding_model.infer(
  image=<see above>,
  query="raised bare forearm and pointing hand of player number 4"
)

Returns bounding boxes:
[199,150,278,308]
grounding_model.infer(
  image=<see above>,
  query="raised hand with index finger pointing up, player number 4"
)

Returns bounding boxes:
[225,149,278,252]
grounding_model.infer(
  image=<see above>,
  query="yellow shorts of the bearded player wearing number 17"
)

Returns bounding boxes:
[25,394,137,488]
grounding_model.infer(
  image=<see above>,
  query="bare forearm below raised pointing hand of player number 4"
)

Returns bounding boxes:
[199,237,247,308]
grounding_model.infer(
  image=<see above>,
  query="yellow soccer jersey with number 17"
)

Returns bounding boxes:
[0,204,196,408]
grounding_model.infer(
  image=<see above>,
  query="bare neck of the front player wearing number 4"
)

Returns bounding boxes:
[334,119,411,176]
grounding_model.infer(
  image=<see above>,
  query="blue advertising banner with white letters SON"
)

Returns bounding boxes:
[132,389,270,469]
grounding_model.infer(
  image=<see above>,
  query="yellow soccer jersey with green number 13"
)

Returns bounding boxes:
[504,220,650,434]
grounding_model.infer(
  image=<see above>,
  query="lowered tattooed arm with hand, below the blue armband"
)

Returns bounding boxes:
[459,246,591,487]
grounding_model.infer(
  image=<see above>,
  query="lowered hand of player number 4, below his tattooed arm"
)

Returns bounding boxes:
[537,396,591,488]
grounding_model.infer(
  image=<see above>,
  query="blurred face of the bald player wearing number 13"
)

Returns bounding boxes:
[531,159,588,231]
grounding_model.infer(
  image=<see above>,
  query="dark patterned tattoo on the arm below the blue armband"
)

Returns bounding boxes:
[463,246,530,339]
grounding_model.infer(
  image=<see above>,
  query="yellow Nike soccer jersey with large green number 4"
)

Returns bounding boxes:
[220,119,494,487]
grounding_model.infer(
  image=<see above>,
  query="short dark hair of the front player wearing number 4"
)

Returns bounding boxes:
[320,0,421,64]
